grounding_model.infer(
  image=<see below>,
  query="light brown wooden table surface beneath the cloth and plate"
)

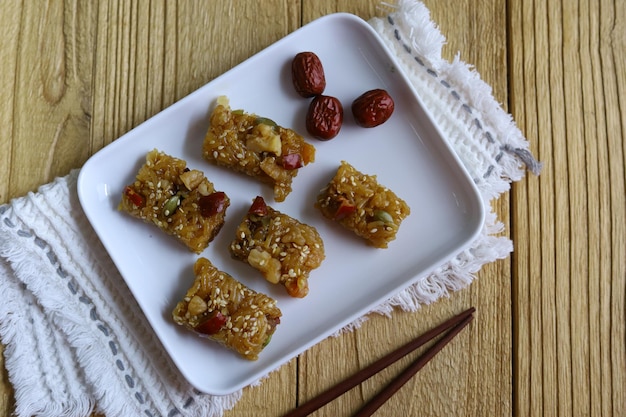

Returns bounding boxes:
[0,0,626,417]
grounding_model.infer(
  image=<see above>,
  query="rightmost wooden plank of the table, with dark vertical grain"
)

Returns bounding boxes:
[509,1,626,416]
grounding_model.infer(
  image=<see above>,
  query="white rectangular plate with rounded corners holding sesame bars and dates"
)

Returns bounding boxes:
[78,13,484,395]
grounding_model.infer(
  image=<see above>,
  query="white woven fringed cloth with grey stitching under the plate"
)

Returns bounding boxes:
[0,0,540,417]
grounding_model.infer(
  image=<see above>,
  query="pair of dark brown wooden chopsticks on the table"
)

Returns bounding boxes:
[284,307,476,417]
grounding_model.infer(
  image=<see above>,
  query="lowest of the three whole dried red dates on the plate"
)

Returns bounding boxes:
[306,96,343,140]
